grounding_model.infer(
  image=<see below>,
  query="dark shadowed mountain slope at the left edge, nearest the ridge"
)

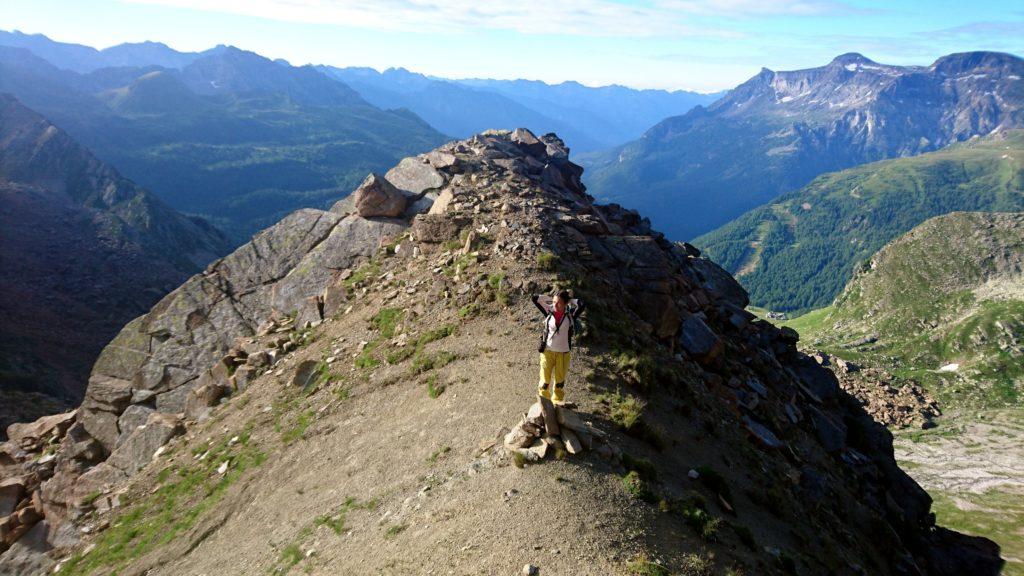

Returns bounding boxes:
[0,94,228,428]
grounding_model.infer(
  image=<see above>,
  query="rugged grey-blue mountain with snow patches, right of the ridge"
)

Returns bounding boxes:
[581,48,1024,240]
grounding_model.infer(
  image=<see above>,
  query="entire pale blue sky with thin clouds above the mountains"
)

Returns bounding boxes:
[0,0,1024,91]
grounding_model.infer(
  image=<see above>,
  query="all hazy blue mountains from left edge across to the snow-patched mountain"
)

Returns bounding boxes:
[0,32,718,240]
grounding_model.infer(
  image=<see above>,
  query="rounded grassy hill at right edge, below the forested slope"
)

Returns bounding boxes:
[791,212,1024,408]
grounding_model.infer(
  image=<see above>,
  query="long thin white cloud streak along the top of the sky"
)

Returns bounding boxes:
[121,0,753,38]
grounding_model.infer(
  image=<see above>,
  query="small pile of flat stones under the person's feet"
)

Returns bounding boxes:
[504,397,623,462]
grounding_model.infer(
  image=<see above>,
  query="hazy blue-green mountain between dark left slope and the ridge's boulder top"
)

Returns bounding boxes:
[0,35,445,245]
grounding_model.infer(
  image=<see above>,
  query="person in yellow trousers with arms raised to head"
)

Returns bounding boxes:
[532,290,584,404]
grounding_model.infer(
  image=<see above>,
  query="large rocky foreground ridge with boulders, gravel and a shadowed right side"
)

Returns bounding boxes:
[0,129,999,575]
